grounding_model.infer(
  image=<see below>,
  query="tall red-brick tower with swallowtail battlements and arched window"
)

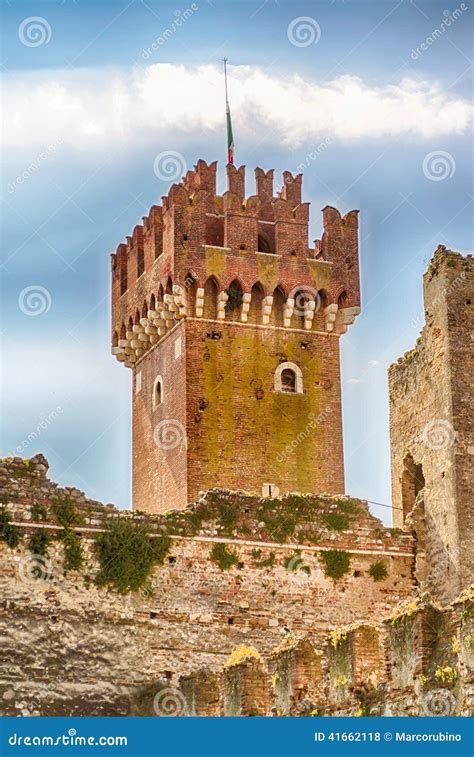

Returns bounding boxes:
[112,160,360,512]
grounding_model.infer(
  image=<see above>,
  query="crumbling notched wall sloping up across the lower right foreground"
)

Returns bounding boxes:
[176,589,474,717]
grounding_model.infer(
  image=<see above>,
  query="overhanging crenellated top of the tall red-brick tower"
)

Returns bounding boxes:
[112,160,360,366]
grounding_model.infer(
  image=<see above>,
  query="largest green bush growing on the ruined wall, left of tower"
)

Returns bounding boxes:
[94,518,172,594]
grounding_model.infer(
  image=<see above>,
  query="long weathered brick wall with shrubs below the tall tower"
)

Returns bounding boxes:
[0,456,415,715]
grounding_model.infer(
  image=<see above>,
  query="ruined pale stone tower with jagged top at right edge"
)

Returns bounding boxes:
[389,246,474,602]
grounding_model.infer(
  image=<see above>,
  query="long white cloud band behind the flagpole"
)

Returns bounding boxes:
[2,63,472,150]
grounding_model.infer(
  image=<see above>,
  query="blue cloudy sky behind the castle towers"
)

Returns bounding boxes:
[1,0,473,520]
